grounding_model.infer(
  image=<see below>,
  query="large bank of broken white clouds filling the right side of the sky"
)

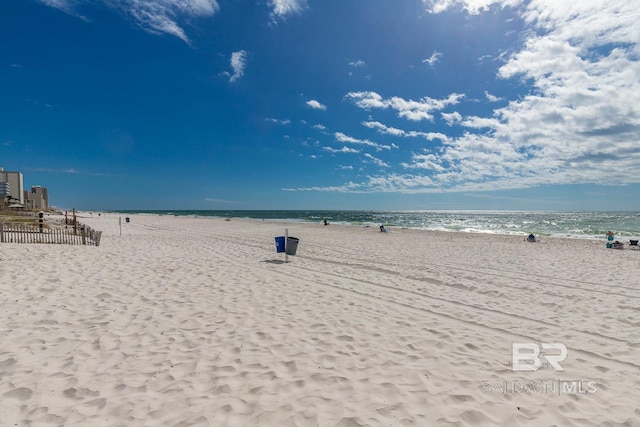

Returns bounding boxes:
[301,0,640,193]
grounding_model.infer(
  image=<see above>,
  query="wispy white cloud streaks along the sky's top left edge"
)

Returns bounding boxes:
[39,0,220,43]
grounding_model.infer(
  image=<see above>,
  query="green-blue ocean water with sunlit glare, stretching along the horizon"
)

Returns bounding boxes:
[110,210,640,240]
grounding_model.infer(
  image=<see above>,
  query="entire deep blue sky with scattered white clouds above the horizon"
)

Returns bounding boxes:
[0,0,640,210]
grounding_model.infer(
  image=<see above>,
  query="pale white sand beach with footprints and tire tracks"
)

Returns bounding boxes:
[0,214,640,427]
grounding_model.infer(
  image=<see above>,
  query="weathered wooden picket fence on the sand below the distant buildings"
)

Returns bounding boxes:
[0,222,102,246]
